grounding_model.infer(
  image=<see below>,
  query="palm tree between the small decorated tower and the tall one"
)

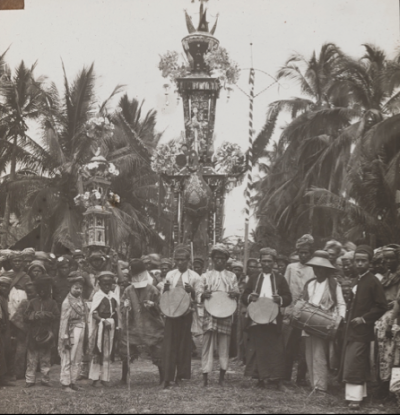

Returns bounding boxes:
[104,95,171,255]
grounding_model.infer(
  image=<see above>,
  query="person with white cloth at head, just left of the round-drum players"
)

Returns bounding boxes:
[120,259,164,384]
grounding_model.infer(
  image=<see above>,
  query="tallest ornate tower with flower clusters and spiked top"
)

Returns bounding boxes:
[152,3,245,260]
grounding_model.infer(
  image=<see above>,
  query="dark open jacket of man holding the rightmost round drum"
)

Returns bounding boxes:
[242,272,292,331]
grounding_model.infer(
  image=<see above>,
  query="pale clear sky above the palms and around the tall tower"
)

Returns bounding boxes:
[0,0,399,242]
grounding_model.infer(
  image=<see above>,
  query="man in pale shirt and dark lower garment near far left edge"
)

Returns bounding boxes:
[7,251,31,380]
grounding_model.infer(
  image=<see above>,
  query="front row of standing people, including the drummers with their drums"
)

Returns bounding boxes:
[0,235,400,409]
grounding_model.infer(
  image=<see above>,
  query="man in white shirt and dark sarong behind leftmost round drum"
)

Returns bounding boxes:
[162,246,202,389]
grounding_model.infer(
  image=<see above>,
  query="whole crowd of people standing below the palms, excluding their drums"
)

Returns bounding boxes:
[0,235,400,409]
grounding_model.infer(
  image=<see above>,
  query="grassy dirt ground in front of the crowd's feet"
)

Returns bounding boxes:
[0,359,400,414]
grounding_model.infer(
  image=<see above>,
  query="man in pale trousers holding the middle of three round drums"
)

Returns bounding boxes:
[201,244,239,386]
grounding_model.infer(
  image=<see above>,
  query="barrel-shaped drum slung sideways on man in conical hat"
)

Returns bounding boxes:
[290,300,342,340]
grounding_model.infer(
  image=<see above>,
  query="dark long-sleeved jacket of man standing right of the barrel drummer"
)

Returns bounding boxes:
[346,272,388,343]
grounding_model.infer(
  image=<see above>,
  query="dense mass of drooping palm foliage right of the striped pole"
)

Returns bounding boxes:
[253,44,400,252]
